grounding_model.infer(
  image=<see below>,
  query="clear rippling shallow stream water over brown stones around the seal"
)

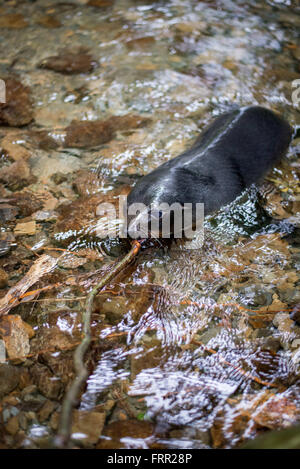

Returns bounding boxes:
[0,0,300,448]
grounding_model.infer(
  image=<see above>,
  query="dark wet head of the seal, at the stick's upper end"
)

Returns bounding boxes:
[127,160,203,239]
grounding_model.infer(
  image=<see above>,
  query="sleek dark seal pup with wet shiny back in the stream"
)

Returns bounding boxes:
[127,106,293,238]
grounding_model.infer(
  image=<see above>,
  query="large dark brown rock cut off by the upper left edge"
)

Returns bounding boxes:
[0,77,33,127]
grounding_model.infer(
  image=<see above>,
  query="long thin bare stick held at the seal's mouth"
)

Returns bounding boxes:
[54,241,141,448]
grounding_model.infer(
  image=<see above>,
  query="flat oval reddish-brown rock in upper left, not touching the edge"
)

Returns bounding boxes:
[40,50,97,74]
